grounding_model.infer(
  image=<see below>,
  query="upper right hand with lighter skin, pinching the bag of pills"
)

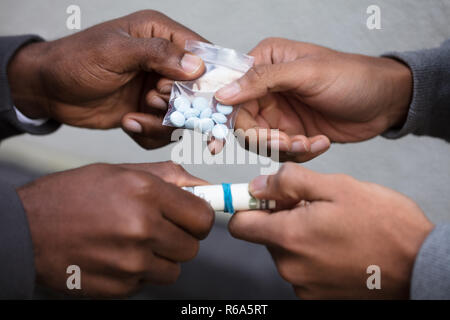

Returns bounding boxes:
[216,38,412,162]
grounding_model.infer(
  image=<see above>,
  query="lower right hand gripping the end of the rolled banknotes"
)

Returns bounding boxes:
[229,163,433,299]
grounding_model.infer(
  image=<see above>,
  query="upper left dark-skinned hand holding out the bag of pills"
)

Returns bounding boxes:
[8,10,204,148]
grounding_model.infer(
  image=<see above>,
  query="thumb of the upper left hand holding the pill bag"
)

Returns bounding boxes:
[124,38,205,80]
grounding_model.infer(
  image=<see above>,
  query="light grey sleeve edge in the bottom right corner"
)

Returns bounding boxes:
[411,224,450,299]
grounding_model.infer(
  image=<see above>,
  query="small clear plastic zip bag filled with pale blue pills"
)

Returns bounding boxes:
[163,40,254,139]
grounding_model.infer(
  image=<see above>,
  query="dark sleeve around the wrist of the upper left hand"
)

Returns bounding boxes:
[0,35,60,141]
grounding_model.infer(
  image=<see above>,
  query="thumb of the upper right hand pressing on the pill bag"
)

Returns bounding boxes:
[215,61,309,105]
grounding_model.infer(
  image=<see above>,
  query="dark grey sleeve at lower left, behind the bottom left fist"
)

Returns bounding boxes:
[0,180,35,299]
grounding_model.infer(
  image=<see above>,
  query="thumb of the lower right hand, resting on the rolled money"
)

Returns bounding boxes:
[249,162,334,203]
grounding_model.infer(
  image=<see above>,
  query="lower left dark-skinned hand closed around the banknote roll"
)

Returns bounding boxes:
[18,162,214,297]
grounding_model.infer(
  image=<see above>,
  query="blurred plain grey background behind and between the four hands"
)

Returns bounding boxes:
[0,0,450,298]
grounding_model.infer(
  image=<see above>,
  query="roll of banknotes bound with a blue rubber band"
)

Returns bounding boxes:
[183,183,276,213]
